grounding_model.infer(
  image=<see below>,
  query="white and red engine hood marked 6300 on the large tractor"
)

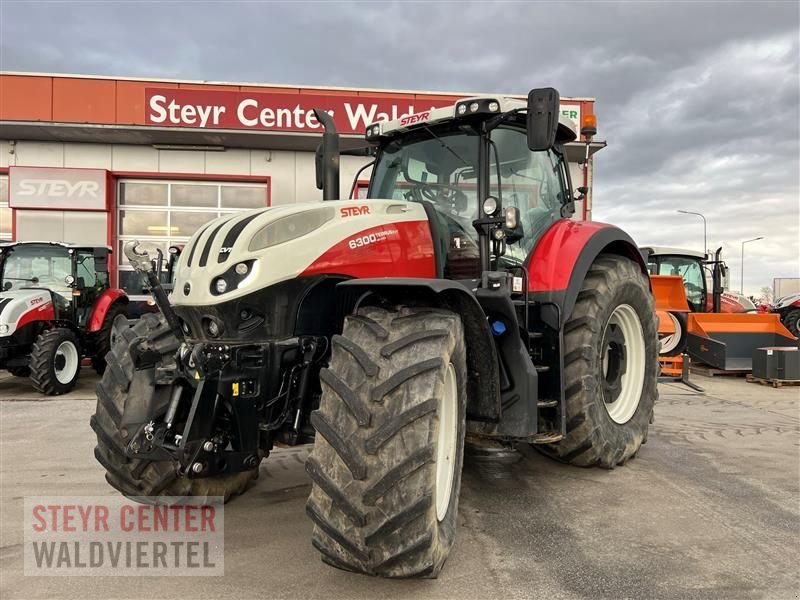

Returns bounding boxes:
[170,200,435,307]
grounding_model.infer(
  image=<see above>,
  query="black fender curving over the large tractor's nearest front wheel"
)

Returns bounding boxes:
[336,278,501,422]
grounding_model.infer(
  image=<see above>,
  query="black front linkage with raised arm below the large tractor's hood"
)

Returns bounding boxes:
[119,242,328,479]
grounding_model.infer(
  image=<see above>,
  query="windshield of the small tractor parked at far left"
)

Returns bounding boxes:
[0,244,72,291]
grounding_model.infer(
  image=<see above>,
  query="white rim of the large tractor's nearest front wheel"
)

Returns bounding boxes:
[436,363,458,521]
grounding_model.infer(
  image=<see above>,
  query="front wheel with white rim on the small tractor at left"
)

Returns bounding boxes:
[29,327,81,396]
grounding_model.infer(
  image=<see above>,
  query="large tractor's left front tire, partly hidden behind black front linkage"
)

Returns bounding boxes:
[90,314,258,504]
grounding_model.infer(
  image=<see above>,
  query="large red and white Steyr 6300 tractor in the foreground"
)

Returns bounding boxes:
[91,88,658,577]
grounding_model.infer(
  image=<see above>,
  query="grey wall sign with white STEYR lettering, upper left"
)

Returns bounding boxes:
[8,167,106,210]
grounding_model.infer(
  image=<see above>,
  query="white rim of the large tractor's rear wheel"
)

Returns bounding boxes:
[601,304,646,425]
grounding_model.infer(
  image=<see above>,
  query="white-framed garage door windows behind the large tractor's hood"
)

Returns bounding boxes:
[115,179,269,299]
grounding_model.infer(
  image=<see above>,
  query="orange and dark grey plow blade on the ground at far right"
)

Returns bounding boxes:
[687,313,797,371]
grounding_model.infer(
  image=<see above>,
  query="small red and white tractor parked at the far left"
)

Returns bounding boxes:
[0,242,128,396]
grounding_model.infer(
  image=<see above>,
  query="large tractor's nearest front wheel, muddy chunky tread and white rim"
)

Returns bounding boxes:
[306,307,467,577]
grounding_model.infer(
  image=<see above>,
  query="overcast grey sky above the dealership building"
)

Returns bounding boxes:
[0,0,800,294]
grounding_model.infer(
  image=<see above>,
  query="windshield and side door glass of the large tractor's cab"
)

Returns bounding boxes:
[369,124,565,264]
